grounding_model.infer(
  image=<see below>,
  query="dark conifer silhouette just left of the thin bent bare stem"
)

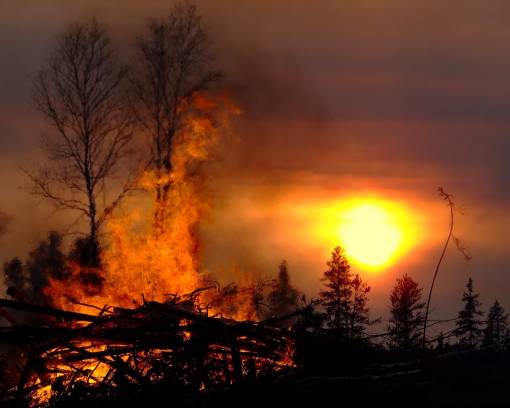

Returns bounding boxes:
[388,274,425,349]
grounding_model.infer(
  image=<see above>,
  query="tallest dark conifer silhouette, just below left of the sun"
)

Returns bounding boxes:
[319,247,370,339]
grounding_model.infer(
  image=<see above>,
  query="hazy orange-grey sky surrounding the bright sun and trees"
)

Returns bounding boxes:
[0,0,510,326]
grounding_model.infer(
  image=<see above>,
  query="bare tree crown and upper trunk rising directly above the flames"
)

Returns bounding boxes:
[131,3,221,230]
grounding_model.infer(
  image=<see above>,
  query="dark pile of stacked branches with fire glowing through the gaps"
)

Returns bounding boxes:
[0,294,291,406]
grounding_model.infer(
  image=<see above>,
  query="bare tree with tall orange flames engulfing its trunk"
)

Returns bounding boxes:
[79,0,237,306]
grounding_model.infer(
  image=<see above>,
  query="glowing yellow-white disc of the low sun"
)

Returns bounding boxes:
[338,201,409,270]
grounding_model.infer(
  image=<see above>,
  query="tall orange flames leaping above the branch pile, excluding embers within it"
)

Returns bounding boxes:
[46,94,239,310]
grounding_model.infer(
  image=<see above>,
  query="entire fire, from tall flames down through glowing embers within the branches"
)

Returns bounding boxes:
[20,95,292,406]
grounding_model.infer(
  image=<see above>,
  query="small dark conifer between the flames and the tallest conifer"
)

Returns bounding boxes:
[268,261,299,316]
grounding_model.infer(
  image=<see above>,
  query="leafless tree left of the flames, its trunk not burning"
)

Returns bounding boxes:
[29,21,132,263]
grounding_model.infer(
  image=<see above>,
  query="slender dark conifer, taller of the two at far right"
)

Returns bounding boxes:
[455,278,483,347]
